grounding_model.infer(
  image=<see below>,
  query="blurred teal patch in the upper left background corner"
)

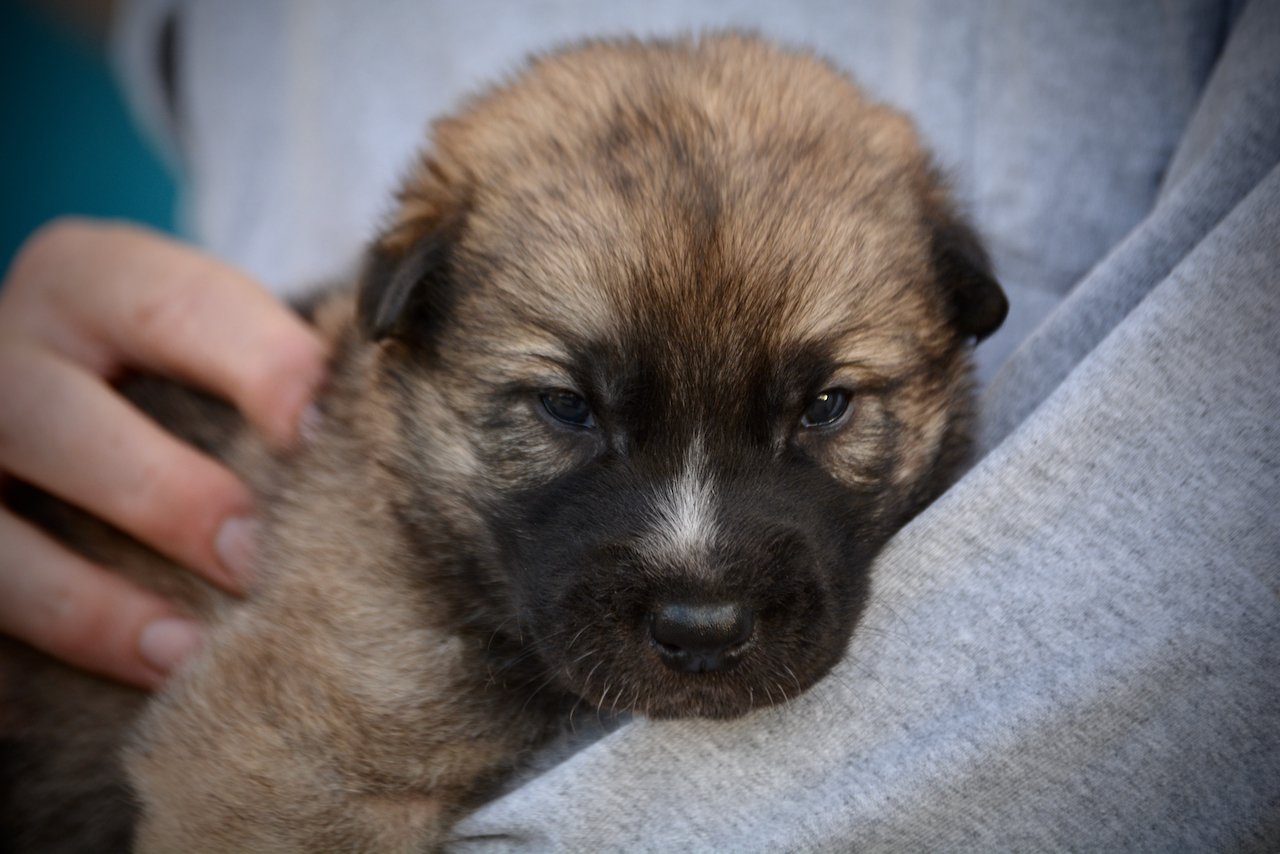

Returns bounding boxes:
[0,0,175,270]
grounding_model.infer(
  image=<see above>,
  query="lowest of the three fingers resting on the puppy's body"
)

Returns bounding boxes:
[0,511,200,688]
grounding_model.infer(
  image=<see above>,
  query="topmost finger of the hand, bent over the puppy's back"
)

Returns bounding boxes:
[10,222,325,446]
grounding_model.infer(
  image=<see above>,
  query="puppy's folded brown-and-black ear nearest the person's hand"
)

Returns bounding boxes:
[356,161,466,346]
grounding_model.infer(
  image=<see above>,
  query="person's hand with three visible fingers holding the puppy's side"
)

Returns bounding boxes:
[0,220,325,688]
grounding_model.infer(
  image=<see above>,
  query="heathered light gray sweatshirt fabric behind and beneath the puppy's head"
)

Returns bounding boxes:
[112,0,1280,850]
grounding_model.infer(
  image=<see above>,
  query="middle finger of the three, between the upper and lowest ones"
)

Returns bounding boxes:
[0,342,252,592]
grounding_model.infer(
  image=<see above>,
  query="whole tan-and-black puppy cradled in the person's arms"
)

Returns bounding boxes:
[4,35,1005,851]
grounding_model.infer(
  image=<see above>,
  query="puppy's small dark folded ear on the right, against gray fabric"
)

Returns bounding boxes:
[929,214,1009,342]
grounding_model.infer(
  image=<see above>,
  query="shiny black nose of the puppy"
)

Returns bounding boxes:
[649,603,754,673]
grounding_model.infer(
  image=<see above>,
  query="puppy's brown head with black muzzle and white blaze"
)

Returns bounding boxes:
[361,37,1004,717]
